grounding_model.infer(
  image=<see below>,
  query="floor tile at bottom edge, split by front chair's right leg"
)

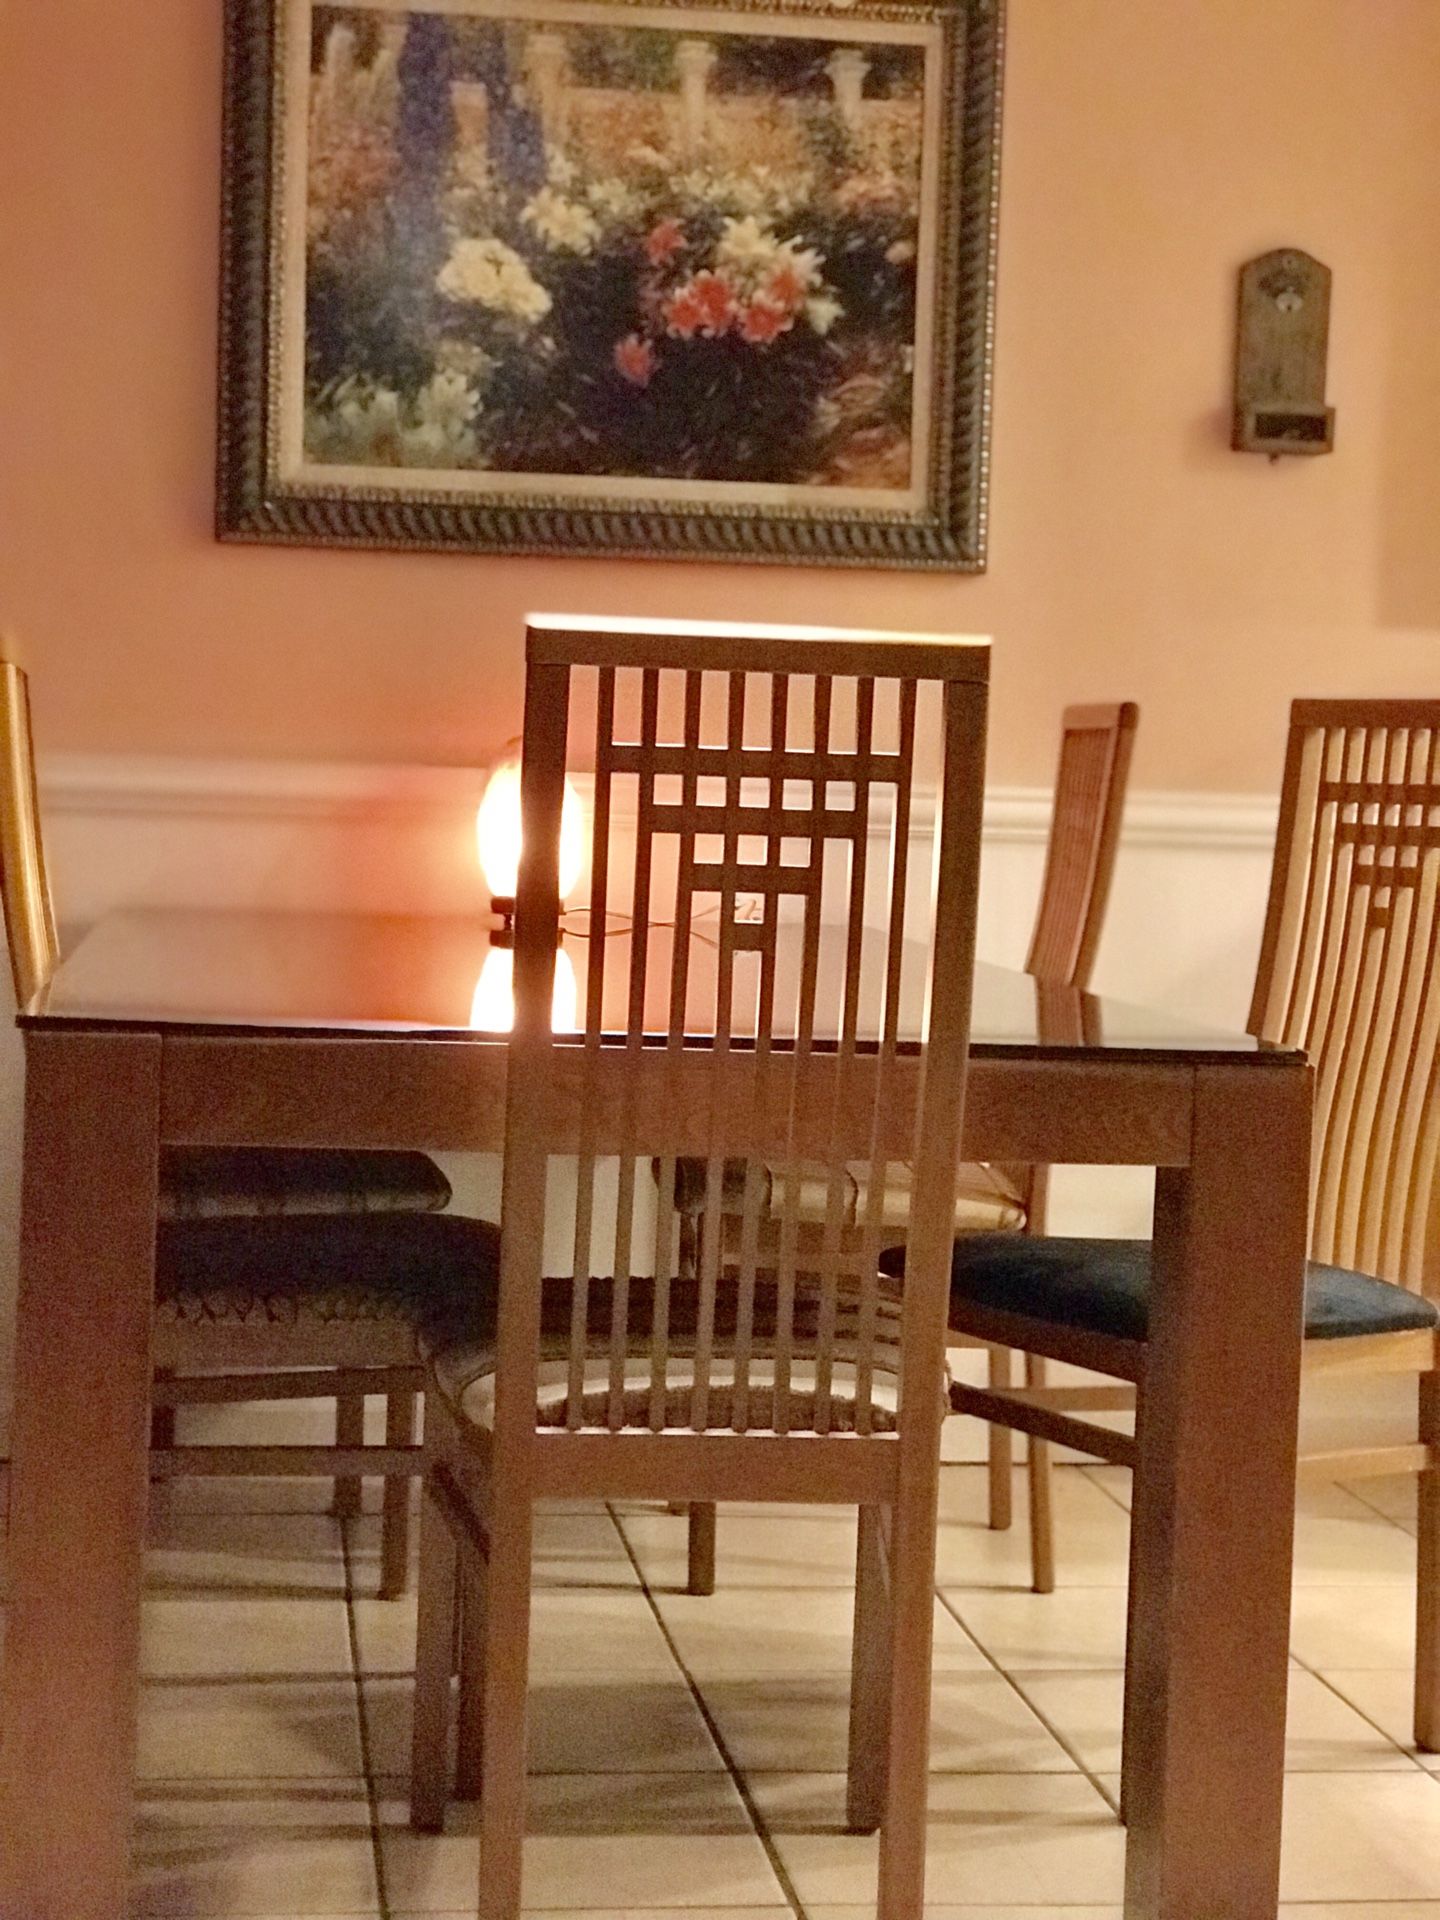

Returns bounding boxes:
[755,1774,1125,1910]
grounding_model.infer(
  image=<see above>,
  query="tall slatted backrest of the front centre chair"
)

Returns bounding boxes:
[495,616,989,1457]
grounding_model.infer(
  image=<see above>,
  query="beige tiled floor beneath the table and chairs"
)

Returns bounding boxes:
[2,1436,1440,1920]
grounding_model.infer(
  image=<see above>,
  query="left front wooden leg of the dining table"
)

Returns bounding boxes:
[0,1033,159,1920]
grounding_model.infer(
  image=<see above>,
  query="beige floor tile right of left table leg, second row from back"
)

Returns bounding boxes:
[140,1596,351,1680]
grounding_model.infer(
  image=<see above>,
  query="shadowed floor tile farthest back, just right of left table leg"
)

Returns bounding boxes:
[146,1513,346,1599]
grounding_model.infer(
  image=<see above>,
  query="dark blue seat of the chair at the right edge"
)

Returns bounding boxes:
[879,1233,1440,1340]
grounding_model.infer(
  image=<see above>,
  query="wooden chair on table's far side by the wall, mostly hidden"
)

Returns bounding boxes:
[680,701,1140,1594]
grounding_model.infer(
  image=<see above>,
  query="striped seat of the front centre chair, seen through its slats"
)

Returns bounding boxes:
[422,1279,899,1432]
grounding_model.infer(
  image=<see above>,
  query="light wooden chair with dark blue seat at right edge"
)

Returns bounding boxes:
[902,701,1440,1781]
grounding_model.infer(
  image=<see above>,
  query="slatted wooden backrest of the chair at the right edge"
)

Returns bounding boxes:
[1250,701,1440,1286]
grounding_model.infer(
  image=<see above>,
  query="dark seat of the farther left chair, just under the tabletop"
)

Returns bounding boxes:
[159,1146,451,1219]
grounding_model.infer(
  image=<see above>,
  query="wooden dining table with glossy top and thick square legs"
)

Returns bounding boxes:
[0,912,1311,1920]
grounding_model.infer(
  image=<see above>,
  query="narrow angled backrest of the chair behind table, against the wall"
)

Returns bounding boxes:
[1025,701,1140,987]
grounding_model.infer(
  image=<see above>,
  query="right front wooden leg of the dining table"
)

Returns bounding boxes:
[1125,1064,1311,1920]
